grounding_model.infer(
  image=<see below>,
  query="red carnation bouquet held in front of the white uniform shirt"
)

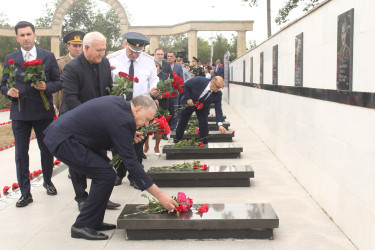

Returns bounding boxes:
[107,72,139,98]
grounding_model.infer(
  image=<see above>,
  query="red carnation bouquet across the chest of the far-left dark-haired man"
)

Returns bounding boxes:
[21,59,51,110]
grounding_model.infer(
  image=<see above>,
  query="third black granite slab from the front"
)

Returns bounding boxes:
[163,143,243,160]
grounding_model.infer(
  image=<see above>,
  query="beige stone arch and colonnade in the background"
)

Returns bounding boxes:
[0,0,253,60]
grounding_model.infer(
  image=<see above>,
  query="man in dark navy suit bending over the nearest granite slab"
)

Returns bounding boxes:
[44,95,178,240]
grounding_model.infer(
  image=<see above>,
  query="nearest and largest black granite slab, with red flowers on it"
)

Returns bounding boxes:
[117,203,279,240]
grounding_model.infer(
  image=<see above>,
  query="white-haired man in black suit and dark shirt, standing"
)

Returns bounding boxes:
[59,32,120,210]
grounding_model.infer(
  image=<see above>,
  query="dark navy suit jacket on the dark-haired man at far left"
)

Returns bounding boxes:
[1,47,61,121]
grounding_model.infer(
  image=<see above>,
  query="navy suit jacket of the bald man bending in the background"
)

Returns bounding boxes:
[181,76,223,123]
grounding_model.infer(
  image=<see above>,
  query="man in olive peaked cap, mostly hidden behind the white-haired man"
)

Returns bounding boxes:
[53,30,85,110]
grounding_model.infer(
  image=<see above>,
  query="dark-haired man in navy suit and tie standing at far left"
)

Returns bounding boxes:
[1,21,61,207]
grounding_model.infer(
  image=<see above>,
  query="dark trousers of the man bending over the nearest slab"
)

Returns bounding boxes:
[54,136,116,228]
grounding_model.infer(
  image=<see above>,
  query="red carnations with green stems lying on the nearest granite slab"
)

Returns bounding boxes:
[124,192,208,217]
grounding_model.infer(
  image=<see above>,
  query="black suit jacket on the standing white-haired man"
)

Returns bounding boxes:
[60,53,112,114]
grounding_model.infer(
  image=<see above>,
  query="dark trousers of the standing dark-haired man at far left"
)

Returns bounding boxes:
[12,118,53,194]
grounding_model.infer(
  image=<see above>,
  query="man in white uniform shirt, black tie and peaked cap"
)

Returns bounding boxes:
[108,32,160,185]
